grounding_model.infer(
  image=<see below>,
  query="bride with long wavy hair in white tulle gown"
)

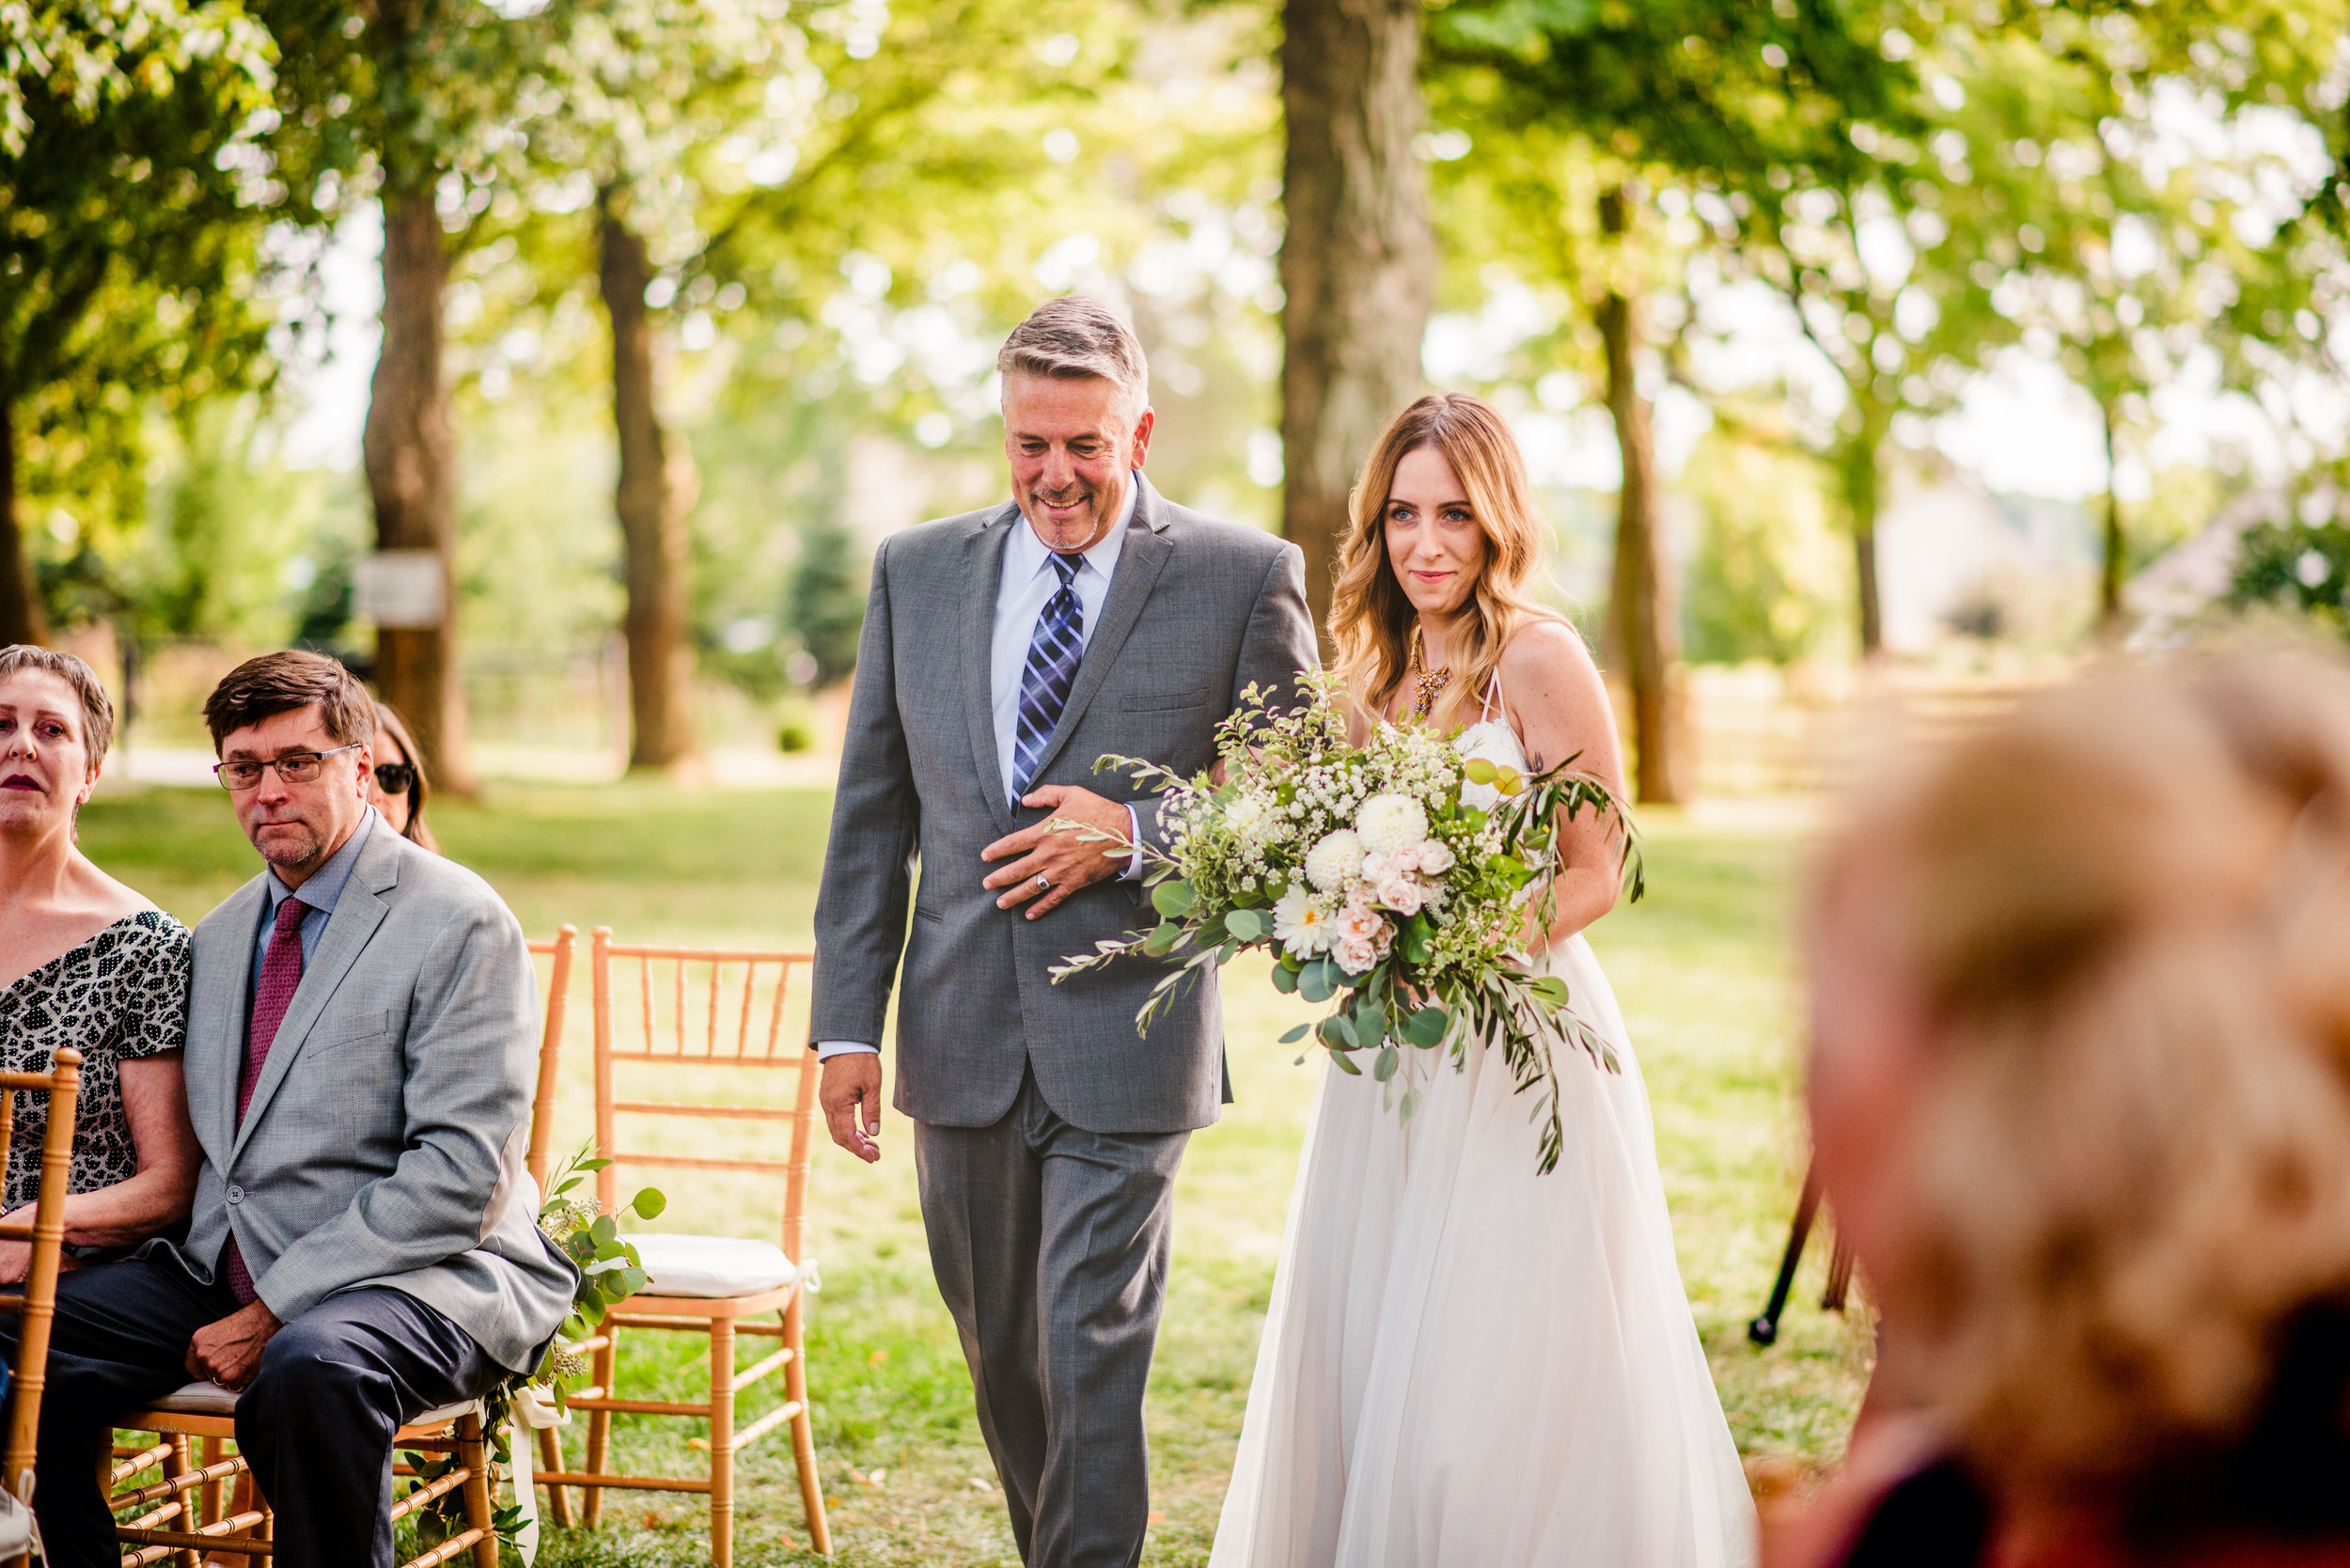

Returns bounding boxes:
[1211,395,1756,1568]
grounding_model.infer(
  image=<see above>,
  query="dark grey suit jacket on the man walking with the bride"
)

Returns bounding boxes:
[808,482,1316,1133]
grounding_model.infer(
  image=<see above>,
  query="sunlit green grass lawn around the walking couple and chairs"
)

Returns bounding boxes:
[83,785,1866,1568]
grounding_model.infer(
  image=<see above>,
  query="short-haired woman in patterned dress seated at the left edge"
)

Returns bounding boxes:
[0,644,202,1281]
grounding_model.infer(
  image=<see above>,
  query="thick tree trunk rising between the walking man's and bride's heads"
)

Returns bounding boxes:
[1281,0,1436,653]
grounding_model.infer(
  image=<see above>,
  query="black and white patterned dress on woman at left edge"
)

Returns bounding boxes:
[0,910,188,1208]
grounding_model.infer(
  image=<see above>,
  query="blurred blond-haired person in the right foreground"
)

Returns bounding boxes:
[1770,653,2350,1568]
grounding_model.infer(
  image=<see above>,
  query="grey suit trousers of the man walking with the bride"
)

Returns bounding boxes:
[915,1074,1192,1568]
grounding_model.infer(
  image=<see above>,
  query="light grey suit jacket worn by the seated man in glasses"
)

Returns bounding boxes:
[150,823,576,1371]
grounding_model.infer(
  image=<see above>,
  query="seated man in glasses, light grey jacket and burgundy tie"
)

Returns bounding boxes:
[10,653,576,1568]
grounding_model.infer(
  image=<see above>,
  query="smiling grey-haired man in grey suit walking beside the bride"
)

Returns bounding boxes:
[811,296,1314,1568]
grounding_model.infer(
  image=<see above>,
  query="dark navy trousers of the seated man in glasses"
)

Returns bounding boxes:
[0,1258,506,1568]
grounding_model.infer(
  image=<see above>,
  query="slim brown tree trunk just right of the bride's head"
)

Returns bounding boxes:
[1598,191,1685,804]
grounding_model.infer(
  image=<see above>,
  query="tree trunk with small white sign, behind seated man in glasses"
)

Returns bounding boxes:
[360,177,475,794]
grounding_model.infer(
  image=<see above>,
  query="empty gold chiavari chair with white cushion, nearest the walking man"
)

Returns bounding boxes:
[540,926,832,1568]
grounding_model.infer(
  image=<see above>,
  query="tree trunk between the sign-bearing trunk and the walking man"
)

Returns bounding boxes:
[597,191,696,769]
